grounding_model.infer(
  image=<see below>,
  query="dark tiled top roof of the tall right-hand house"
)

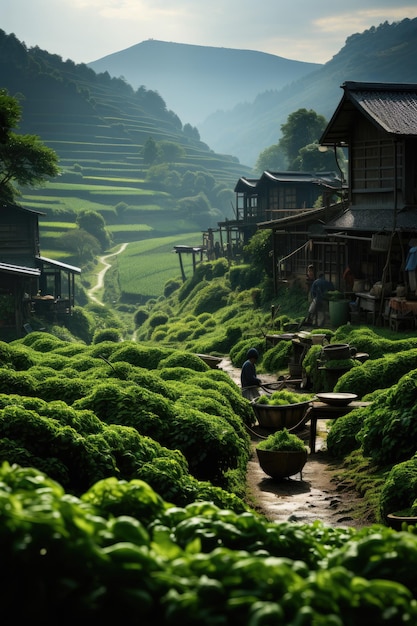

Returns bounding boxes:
[320,81,417,145]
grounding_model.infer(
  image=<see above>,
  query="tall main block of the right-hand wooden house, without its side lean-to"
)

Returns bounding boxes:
[320,82,417,291]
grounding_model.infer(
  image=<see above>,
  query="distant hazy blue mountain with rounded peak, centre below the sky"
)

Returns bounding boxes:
[87,39,321,125]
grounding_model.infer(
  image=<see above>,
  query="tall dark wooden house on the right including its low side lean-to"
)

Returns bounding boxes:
[258,82,417,302]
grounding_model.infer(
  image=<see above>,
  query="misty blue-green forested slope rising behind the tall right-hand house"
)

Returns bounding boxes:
[198,18,417,166]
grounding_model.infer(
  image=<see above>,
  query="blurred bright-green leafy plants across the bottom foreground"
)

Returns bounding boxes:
[0,456,417,626]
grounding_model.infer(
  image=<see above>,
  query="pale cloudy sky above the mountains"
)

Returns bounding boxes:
[0,0,417,63]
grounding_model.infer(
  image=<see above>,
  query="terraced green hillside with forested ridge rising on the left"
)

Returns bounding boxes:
[0,31,249,248]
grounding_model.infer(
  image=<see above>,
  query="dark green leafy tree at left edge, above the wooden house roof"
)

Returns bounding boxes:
[0,90,59,202]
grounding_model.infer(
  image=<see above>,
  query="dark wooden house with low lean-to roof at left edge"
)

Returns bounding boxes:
[0,201,81,340]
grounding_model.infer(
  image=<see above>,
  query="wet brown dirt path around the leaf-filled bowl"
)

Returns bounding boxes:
[219,359,370,528]
